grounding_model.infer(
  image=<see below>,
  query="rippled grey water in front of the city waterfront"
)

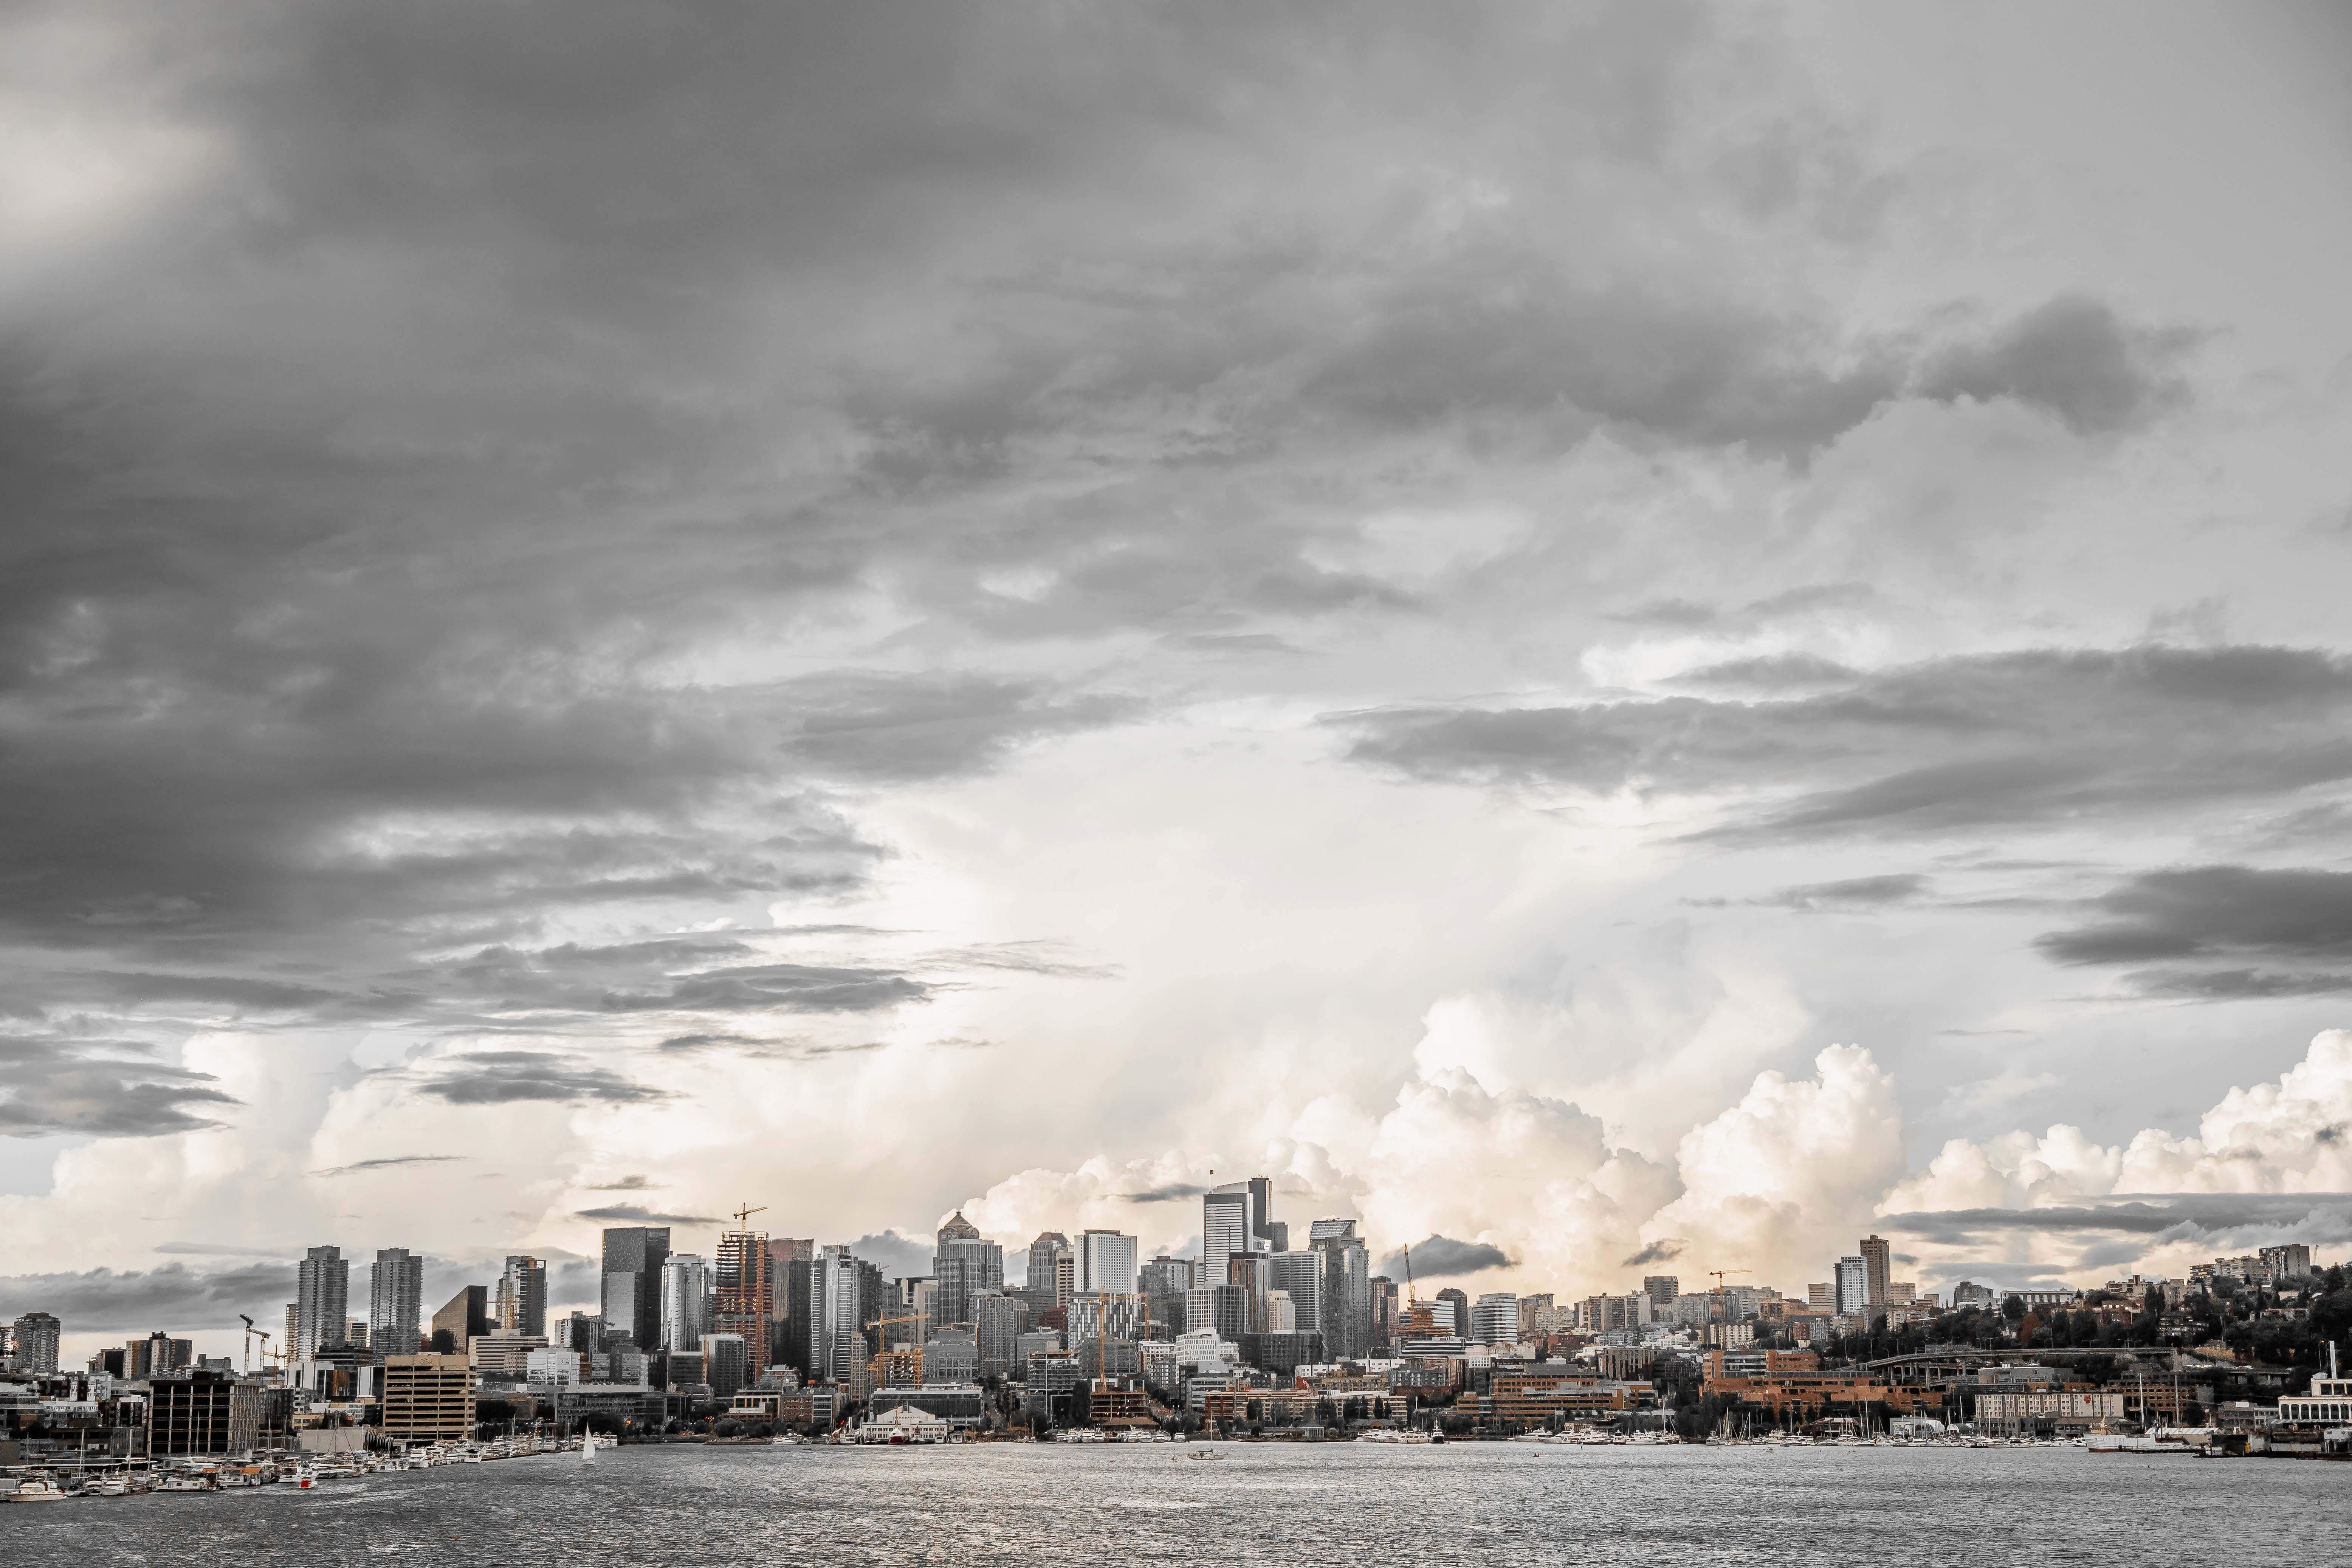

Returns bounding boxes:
[0,1443,2352,1568]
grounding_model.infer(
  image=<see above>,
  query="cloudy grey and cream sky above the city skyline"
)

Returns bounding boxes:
[0,0,2352,1350]
